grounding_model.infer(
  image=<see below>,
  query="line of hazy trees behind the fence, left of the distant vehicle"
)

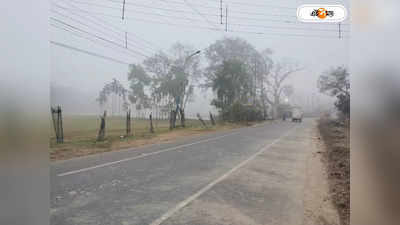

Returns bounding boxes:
[97,38,302,126]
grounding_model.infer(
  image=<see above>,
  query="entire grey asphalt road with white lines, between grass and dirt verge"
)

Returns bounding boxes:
[50,120,313,225]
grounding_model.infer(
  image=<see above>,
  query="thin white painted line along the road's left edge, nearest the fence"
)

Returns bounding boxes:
[57,132,239,177]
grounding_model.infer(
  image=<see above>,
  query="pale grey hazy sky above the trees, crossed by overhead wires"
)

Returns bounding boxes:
[50,0,350,115]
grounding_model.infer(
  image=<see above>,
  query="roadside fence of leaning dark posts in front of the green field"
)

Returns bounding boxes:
[52,108,217,145]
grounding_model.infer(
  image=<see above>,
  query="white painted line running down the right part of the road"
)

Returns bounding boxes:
[150,127,297,225]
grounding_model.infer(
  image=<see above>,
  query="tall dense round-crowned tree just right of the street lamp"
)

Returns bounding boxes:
[203,38,263,114]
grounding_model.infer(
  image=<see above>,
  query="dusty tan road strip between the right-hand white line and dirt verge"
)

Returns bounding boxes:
[162,125,309,225]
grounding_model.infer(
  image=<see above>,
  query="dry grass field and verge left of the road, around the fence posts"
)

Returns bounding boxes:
[50,116,241,161]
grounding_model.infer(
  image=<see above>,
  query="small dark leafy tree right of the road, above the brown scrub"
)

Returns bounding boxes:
[317,66,350,116]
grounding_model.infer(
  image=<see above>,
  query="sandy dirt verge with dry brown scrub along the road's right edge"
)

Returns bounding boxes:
[304,118,350,225]
